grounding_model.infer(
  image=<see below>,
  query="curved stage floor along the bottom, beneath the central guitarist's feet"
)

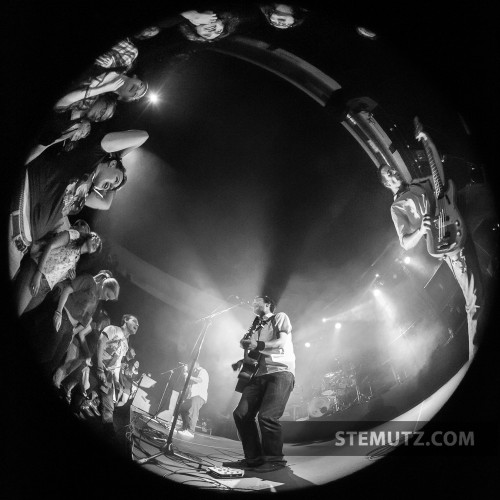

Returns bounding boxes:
[130,363,468,492]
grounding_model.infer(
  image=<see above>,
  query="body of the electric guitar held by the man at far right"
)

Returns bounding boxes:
[427,180,467,258]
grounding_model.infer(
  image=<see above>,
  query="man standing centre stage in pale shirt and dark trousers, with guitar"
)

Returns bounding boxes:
[228,295,295,472]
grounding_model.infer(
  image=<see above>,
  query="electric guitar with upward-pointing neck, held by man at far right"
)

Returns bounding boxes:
[414,117,467,258]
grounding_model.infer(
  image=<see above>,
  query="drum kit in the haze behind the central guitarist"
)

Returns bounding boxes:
[308,357,371,418]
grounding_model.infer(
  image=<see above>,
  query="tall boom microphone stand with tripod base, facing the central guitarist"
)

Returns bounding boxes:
[136,303,241,468]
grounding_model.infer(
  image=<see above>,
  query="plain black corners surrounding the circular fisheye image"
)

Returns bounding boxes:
[1,0,500,498]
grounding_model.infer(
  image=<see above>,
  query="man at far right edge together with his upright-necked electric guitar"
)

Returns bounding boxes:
[379,118,482,359]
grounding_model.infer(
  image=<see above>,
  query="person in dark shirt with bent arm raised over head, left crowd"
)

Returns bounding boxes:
[9,130,149,278]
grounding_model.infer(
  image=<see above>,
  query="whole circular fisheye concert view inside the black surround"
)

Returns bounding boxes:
[9,3,499,492]
